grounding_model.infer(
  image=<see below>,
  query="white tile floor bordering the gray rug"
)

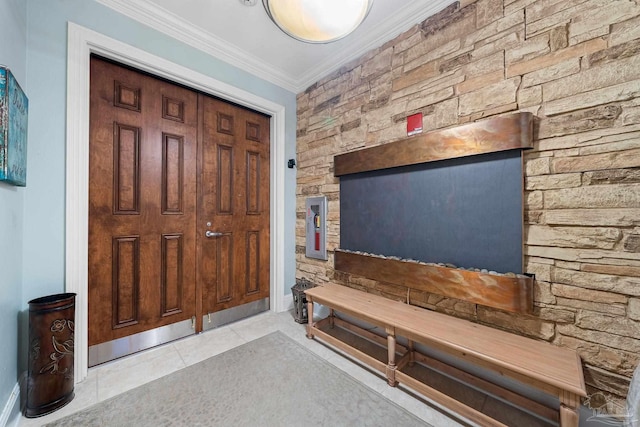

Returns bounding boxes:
[18,312,462,427]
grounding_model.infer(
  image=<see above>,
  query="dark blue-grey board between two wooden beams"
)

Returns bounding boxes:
[340,150,523,273]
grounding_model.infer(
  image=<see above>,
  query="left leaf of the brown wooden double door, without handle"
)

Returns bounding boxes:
[89,58,197,346]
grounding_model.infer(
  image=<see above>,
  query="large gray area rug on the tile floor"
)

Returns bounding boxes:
[47,332,427,427]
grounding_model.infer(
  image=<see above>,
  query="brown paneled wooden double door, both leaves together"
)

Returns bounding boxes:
[88,57,270,358]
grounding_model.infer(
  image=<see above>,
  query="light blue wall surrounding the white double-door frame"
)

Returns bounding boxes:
[23,0,296,301]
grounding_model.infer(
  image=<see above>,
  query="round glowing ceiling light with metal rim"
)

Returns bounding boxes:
[262,0,373,43]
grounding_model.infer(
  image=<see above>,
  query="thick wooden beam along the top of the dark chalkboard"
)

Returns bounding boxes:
[334,112,533,176]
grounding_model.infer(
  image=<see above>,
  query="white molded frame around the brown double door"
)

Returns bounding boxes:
[65,22,286,382]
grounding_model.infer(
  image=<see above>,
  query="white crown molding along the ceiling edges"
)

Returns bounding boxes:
[95,0,451,93]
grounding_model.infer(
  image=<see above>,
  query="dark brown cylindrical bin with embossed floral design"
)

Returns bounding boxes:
[25,293,76,418]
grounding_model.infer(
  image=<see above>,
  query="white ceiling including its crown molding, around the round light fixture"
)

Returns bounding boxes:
[96,0,454,93]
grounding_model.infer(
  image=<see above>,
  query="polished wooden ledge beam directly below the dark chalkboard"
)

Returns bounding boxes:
[334,250,534,314]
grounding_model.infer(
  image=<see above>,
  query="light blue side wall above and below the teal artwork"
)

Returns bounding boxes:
[0,0,30,418]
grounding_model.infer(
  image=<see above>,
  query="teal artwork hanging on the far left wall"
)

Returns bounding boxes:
[0,66,29,187]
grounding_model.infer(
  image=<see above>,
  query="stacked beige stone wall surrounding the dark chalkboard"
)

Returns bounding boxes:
[296,0,640,403]
